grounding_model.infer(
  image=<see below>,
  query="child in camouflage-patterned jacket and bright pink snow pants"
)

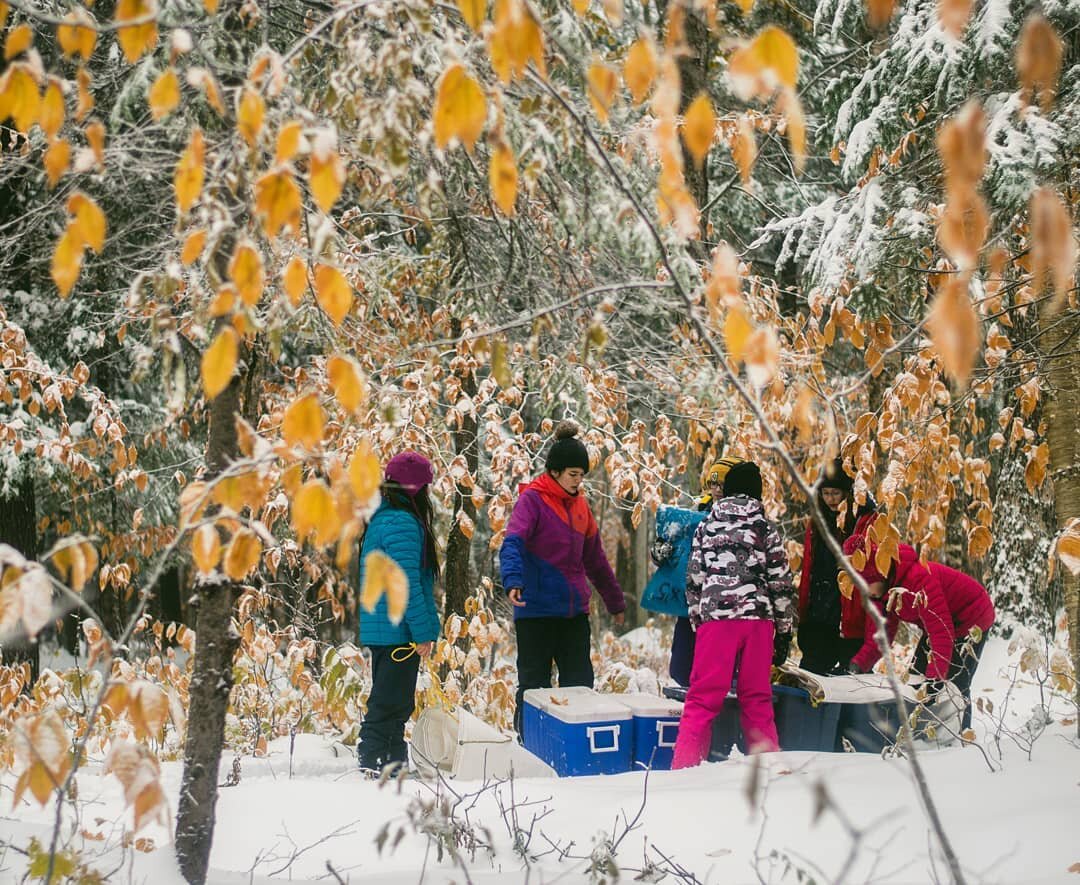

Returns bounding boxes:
[672,461,795,768]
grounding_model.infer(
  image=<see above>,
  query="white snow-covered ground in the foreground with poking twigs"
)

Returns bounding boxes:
[0,640,1080,885]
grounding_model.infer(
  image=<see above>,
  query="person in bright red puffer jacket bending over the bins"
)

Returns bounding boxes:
[843,520,995,729]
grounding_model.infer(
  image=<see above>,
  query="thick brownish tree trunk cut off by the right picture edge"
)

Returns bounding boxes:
[1037,316,1080,735]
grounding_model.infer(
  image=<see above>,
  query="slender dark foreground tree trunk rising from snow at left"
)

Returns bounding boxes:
[176,354,244,885]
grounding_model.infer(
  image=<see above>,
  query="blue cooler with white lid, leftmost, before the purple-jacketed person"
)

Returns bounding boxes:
[522,686,633,777]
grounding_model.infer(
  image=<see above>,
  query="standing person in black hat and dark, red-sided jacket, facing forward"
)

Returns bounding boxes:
[798,458,875,675]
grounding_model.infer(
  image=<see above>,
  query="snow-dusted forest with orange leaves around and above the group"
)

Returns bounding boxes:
[0,0,1080,882]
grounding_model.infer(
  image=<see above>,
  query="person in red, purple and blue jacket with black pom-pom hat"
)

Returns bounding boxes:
[499,421,626,734]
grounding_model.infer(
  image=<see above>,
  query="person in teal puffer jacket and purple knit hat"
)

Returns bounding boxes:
[356,452,438,776]
